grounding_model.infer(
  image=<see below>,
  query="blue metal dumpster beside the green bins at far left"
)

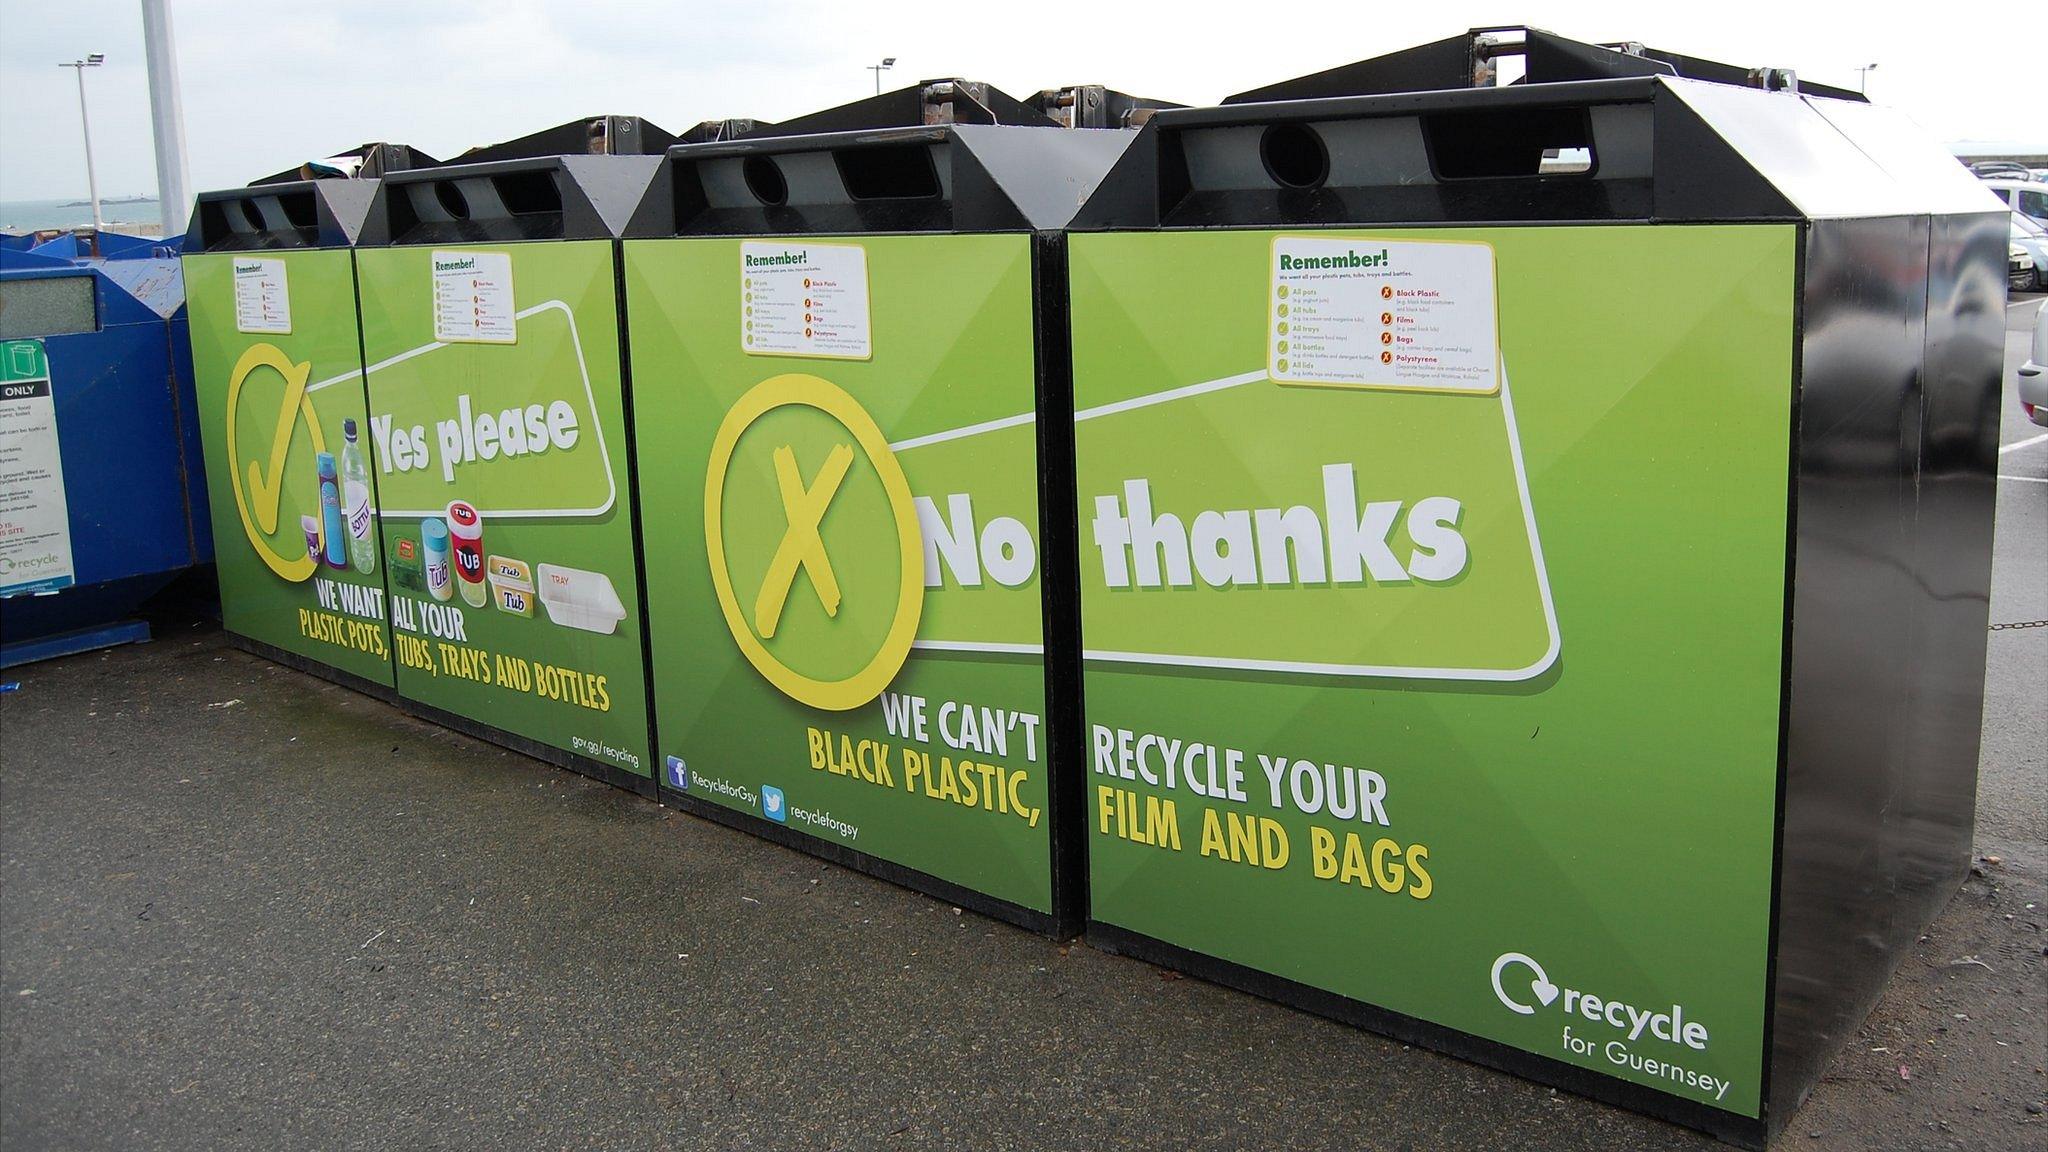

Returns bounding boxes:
[0,234,211,666]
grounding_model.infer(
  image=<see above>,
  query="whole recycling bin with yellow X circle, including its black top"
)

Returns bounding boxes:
[625,118,1130,933]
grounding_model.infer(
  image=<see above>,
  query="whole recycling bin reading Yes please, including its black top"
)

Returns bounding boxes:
[356,156,657,791]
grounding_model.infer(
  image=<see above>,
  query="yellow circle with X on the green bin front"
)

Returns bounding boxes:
[705,373,924,711]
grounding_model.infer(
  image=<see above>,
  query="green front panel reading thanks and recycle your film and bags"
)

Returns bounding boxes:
[1071,225,1798,1117]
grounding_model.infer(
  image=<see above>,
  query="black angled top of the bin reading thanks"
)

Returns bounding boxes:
[1071,29,1987,230]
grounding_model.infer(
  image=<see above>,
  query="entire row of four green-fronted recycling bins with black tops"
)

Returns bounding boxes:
[186,33,2005,1142]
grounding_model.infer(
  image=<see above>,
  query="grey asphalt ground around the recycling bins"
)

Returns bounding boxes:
[0,303,2048,1152]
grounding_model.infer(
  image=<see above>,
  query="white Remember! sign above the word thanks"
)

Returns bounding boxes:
[1266,236,1501,396]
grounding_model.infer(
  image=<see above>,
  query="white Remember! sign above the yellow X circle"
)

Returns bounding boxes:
[739,240,874,361]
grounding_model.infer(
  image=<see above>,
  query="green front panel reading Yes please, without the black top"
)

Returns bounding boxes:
[356,240,651,777]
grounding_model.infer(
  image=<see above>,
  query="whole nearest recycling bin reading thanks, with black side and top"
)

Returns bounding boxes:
[1069,31,2005,1144]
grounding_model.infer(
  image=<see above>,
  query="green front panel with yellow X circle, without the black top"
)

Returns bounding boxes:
[625,234,1053,912]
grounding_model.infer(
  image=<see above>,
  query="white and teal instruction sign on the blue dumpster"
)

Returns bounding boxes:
[0,340,76,596]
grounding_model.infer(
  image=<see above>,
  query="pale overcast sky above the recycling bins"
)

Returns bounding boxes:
[0,0,2048,201]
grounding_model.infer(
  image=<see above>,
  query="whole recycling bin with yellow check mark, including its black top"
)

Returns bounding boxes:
[184,180,393,684]
